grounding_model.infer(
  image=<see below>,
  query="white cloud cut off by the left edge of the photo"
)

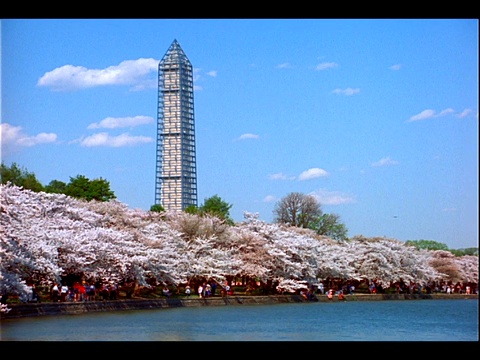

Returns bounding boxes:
[0,123,57,155]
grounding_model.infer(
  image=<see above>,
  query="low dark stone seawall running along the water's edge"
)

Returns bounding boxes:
[0,294,478,319]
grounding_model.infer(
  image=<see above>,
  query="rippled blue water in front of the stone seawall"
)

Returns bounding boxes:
[1,299,479,341]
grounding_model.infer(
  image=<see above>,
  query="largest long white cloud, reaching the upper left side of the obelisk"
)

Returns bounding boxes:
[37,58,159,91]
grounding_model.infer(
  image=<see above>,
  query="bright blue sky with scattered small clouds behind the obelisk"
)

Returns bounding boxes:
[1,19,479,249]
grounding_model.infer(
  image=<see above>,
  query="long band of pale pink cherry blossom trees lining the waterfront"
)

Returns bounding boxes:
[0,183,478,295]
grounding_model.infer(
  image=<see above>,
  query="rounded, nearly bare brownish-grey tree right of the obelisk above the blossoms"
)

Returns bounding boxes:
[273,192,323,228]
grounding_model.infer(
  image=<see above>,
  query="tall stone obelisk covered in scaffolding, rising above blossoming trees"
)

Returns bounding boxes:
[155,39,198,211]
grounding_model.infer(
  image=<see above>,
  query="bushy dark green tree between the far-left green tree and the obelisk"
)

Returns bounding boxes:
[65,175,116,201]
